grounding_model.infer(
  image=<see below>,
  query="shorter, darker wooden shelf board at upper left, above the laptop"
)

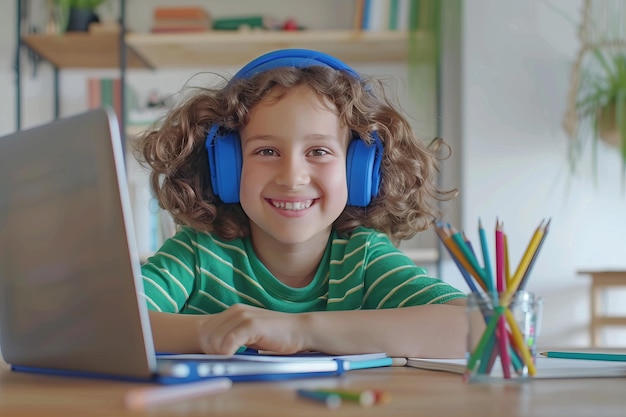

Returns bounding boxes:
[22,32,146,68]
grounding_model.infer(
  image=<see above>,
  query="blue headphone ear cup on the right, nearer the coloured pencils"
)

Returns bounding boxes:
[346,132,382,207]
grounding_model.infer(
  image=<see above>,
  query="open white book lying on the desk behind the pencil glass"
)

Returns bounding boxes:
[406,356,626,379]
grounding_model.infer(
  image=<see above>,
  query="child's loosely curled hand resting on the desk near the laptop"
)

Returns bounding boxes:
[199,304,306,355]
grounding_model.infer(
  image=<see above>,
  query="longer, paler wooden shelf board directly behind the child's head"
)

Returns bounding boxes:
[126,30,412,68]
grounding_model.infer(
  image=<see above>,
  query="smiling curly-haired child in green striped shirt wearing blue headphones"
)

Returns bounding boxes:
[138,49,466,357]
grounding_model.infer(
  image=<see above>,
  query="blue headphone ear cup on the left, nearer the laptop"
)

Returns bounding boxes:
[205,126,242,204]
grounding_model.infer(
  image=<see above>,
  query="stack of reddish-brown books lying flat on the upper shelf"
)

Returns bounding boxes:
[152,6,211,33]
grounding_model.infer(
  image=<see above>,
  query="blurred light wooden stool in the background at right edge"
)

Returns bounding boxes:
[578,270,626,347]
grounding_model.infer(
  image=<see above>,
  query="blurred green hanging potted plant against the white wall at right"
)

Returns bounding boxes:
[565,47,626,177]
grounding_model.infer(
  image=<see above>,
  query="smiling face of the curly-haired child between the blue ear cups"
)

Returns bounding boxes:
[240,86,349,244]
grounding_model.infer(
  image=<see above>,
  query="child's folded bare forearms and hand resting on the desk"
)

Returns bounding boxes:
[150,300,467,358]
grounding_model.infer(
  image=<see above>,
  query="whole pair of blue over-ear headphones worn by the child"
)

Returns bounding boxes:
[205,49,383,207]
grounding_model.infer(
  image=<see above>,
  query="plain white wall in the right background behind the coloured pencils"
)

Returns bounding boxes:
[444,0,626,346]
